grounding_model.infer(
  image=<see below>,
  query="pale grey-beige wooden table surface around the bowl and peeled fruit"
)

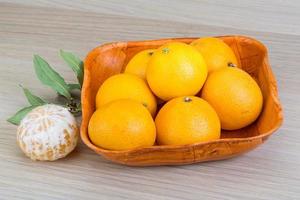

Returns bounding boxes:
[0,0,300,200]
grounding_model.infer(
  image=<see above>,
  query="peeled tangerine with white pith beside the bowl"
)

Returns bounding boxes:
[17,104,79,161]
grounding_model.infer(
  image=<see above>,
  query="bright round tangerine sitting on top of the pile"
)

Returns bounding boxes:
[146,42,207,101]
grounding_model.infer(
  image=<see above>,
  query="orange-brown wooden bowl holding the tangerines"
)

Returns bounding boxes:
[81,36,283,166]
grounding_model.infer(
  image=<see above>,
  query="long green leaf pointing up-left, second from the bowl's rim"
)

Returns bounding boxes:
[33,55,71,99]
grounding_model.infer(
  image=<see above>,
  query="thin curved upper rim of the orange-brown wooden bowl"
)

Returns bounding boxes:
[80,35,283,154]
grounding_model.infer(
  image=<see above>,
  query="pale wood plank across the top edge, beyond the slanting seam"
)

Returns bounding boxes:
[0,0,300,34]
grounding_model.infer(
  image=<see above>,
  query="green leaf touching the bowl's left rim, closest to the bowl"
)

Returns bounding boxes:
[59,49,83,86]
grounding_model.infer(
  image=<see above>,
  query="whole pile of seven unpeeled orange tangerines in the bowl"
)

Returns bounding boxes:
[88,37,263,150]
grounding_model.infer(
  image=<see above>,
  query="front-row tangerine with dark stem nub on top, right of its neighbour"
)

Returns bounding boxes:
[155,96,221,145]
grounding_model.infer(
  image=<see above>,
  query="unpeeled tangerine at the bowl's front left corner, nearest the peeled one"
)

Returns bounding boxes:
[88,99,156,150]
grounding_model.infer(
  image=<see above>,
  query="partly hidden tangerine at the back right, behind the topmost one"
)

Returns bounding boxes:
[191,37,238,73]
